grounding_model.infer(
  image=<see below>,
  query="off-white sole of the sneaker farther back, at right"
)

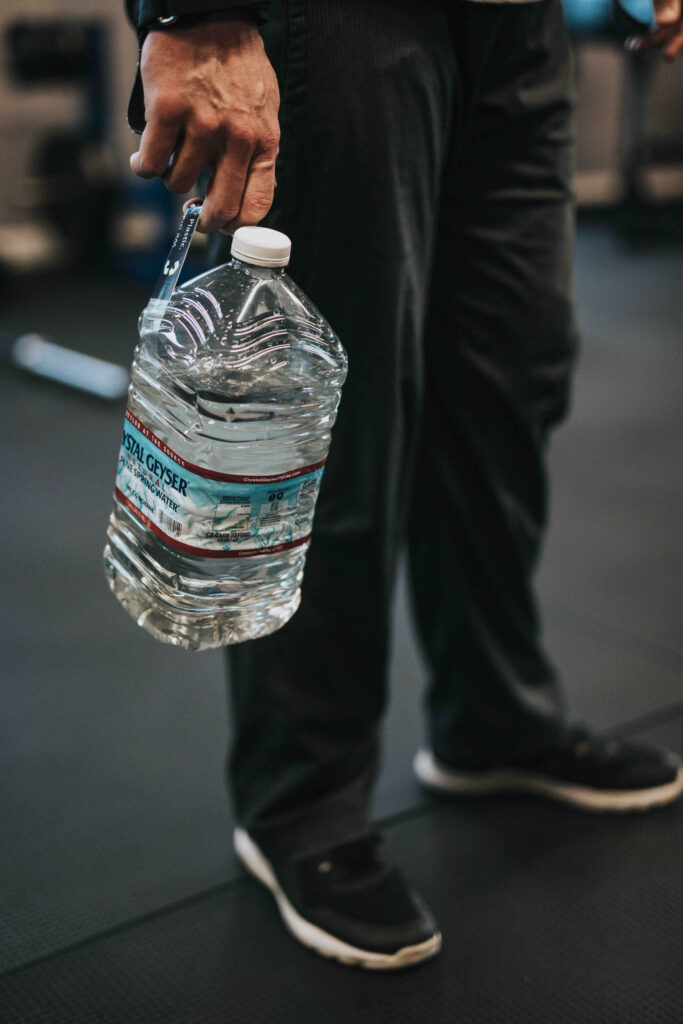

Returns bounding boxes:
[413,751,683,813]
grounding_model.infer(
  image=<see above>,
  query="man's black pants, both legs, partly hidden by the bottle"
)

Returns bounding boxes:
[210,0,575,852]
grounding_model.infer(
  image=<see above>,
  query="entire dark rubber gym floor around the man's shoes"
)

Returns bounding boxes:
[0,211,683,1024]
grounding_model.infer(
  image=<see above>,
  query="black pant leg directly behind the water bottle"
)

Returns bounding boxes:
[216,0,456,850]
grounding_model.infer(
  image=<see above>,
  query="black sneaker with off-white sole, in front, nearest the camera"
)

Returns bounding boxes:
[234,828,441,970]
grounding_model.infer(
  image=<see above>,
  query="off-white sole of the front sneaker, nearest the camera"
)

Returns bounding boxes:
[232,828,441,971]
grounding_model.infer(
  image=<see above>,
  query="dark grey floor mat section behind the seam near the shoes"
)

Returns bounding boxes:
[0,229,683,974]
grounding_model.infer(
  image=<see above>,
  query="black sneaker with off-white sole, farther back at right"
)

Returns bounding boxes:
[414,726,683,811]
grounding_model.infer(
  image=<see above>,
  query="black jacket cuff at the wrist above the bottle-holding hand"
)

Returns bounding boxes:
[125,0,268,134]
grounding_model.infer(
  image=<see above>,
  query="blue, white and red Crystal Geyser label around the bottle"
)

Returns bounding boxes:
[116,410,325,558]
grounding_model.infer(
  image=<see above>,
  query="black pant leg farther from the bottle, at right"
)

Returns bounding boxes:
[410,0,575,763]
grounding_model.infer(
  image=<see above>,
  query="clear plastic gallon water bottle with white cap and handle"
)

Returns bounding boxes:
[104,207,346,650]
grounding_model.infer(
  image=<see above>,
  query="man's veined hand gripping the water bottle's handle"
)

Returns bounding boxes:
[130,17,280,233]
